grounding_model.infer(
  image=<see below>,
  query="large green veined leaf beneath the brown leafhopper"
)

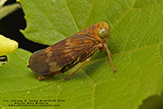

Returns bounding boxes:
[0,0,163,109]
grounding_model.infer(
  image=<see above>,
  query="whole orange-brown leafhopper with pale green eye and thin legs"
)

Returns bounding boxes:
[28,22,116,80]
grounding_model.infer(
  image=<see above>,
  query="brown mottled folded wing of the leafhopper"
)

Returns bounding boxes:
[29,34,96,74]
